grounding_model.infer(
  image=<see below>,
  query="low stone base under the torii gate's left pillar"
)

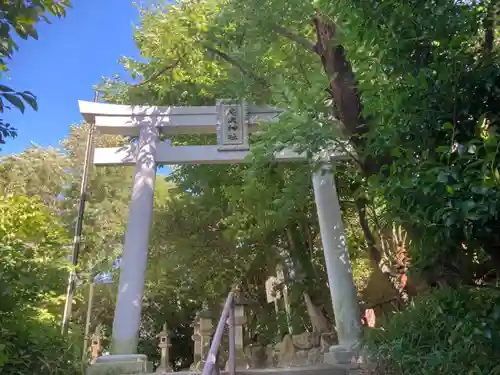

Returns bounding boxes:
[85,354,153,375]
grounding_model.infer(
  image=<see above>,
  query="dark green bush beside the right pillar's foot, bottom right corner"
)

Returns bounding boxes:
[365,288,500,375]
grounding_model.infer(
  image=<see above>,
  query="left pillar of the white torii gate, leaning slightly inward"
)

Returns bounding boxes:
[112,121,158,354]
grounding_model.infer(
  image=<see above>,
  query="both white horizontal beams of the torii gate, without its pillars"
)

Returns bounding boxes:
[79,101,346,165]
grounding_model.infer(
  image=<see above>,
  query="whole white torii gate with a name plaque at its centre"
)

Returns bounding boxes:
[78,100,361,368]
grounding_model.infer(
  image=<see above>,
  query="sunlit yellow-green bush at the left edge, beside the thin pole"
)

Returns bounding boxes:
[0,196,82,375]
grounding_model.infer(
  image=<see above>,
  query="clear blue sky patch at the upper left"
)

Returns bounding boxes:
[0,0,139,154]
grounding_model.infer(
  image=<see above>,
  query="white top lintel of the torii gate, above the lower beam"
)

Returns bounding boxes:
[78,99,283,136]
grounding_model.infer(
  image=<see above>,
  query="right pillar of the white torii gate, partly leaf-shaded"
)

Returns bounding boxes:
[313,166,361,349]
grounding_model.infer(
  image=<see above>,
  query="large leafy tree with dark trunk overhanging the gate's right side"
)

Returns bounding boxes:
[101,0,499,287]
